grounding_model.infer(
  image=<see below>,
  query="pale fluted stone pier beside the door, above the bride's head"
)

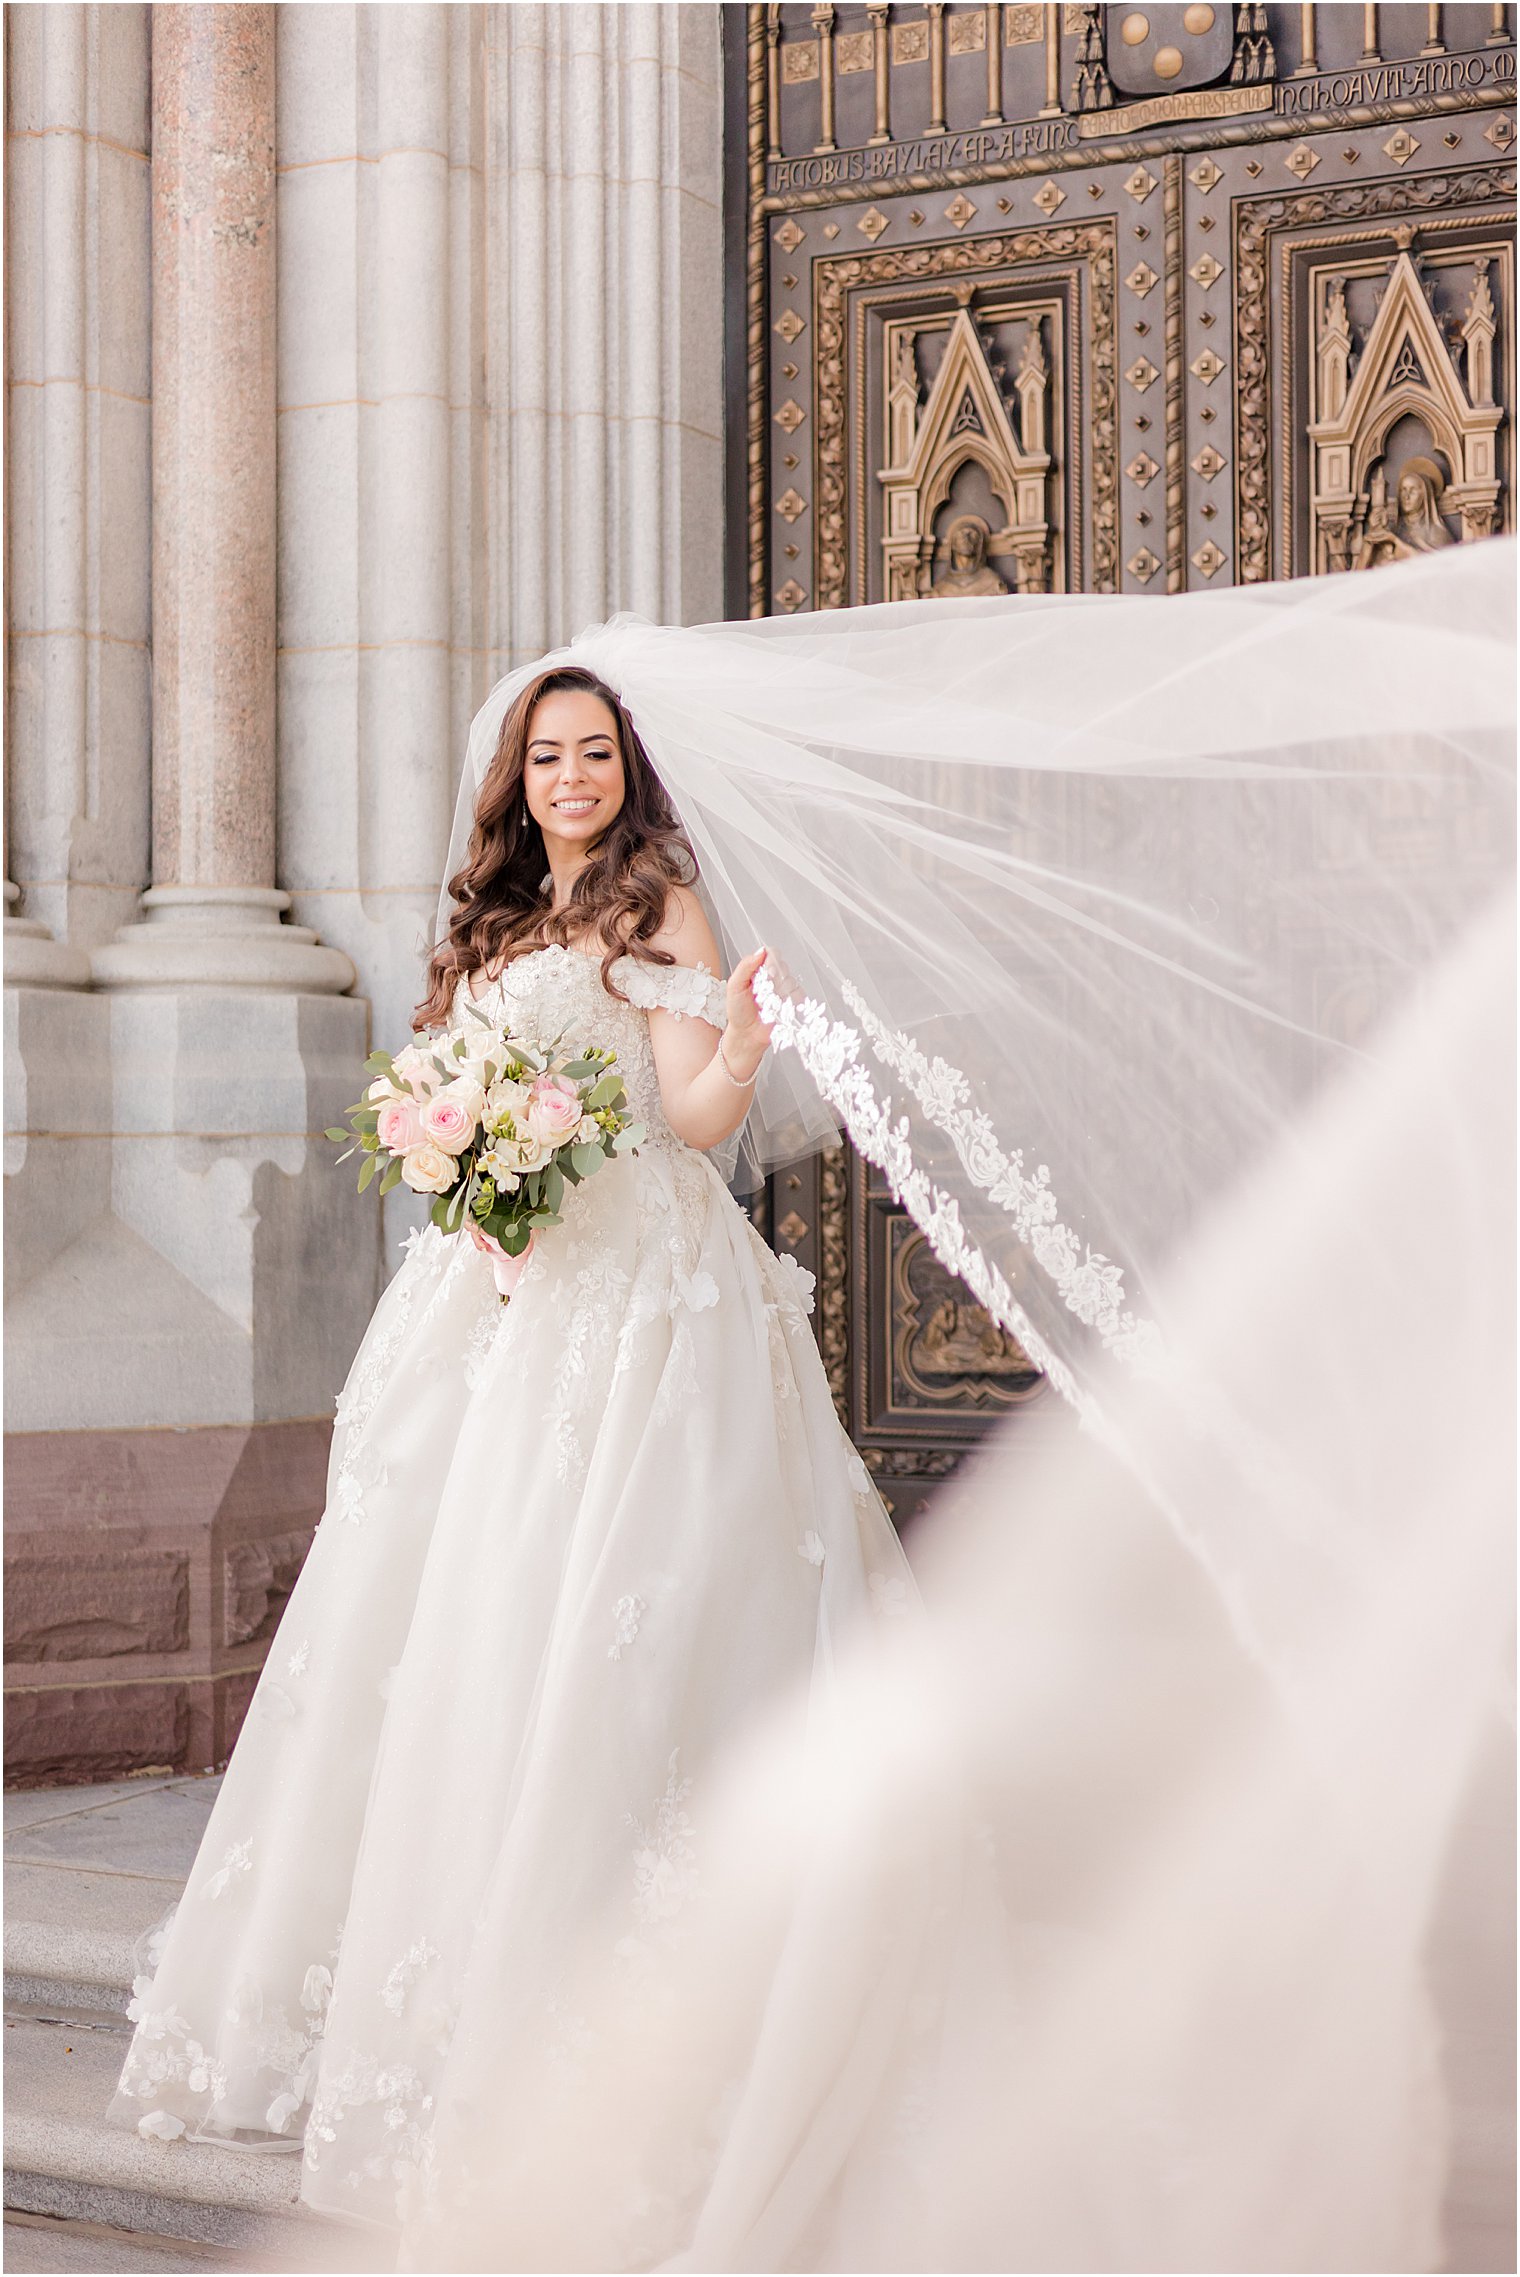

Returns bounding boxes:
[485,0,724,669]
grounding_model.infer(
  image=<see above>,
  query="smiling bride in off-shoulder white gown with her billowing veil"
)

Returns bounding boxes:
[114,542,1513,2270]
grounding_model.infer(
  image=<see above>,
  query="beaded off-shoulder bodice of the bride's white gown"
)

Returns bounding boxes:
[448,943,728,1141]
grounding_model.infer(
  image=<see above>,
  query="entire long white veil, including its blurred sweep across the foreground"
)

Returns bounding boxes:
[407,542,1513,2270]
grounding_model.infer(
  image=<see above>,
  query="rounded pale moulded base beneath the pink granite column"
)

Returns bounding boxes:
[91,886,355,995]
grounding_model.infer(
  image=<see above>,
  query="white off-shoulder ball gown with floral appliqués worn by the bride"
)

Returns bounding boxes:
[111,947,912,2222]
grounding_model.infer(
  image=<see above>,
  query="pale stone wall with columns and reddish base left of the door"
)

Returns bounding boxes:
[5,5,721,1783]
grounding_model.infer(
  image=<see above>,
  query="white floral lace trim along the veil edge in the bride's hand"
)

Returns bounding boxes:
[755,968,1165,1425]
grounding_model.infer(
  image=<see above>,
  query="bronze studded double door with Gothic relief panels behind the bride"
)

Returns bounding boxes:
[726,0,1515,1519]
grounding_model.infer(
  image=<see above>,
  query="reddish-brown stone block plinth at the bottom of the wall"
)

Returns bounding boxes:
[5,1419,332,1787]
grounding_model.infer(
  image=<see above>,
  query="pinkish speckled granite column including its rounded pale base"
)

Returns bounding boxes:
[93,5,355,993]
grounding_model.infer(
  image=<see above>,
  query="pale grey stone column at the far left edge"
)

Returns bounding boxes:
[5,5,148,988]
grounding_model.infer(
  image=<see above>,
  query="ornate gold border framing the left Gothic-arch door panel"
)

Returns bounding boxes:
[815,219,1120,608]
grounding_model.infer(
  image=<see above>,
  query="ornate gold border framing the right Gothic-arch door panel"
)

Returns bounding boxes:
[1236,164,1515,583]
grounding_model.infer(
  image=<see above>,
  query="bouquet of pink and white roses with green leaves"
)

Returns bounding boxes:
[328,1006,644,1298]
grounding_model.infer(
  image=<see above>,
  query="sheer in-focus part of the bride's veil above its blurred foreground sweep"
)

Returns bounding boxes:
[441,540,1513,1416]
